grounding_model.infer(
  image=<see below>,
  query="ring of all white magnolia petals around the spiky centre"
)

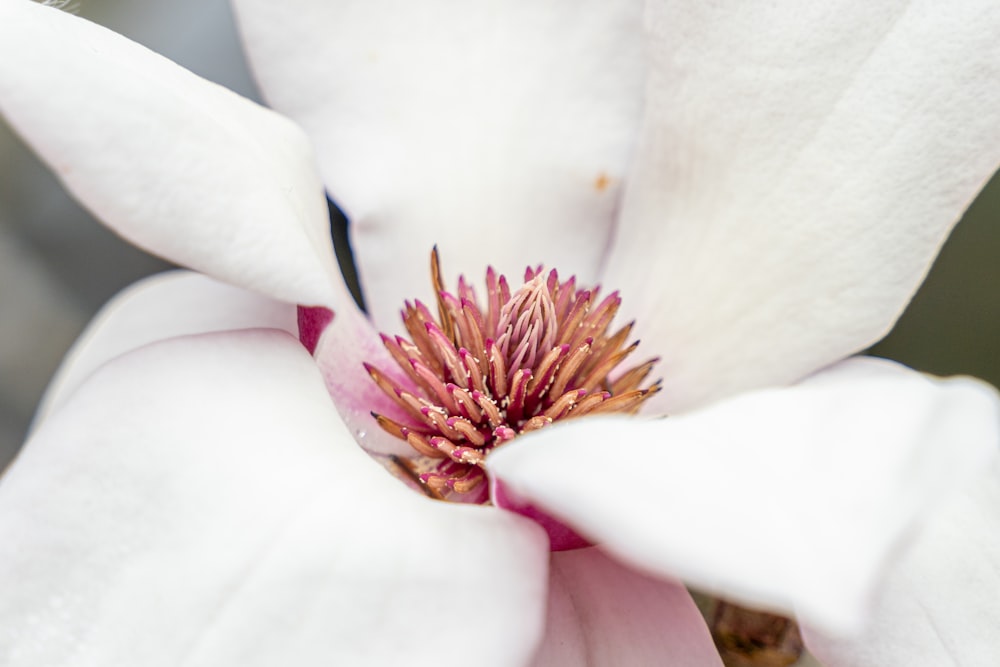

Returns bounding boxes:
[0,0,1000,666]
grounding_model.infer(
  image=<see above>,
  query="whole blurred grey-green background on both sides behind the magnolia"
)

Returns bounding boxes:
[0,0,1000,469]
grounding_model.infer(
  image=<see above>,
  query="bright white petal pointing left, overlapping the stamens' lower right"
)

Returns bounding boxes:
[488,359,1000,630]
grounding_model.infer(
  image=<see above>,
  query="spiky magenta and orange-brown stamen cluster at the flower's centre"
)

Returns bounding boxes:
[365,248,660,503]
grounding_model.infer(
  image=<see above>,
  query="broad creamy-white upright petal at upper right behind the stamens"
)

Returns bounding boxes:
[603,0,1000,412]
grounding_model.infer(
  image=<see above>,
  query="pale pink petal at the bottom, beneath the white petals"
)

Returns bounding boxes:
[535,548,722,667]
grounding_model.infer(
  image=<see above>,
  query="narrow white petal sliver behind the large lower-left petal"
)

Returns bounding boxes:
[35,271,297,427]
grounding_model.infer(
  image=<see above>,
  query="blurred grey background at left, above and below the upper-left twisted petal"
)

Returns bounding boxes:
[0,0,258,467]
